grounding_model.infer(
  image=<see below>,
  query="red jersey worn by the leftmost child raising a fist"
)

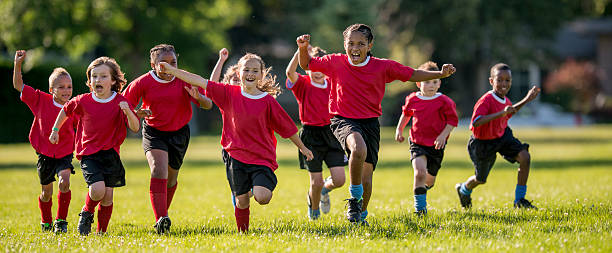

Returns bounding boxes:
[21,84,74,158]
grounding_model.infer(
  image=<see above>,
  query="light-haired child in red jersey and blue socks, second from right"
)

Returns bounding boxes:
[395,61,458,215]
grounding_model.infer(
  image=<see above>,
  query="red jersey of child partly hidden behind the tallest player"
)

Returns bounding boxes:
[287,74,331,126]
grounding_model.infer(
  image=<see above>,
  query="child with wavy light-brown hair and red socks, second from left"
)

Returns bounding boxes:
[49,57,140,235]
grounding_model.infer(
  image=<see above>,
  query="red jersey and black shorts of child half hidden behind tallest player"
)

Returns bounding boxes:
[286,74,348,172]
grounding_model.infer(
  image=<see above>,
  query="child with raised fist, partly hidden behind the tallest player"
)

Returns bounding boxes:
[286,47,348,220]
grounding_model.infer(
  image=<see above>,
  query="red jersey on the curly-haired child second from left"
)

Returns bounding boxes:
[64,92,133,160]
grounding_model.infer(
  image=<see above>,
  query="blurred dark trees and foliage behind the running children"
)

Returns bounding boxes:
[0,0,612,143]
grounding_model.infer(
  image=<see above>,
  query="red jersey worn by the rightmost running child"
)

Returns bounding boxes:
[470,91,512,140]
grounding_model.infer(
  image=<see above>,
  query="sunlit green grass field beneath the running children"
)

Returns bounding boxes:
[0,126,612,252]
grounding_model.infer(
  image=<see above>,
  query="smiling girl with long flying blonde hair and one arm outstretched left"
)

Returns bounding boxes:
[160,53,313,232]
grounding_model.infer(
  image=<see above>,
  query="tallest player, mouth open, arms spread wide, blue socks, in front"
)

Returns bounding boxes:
[296,24,455,223]
